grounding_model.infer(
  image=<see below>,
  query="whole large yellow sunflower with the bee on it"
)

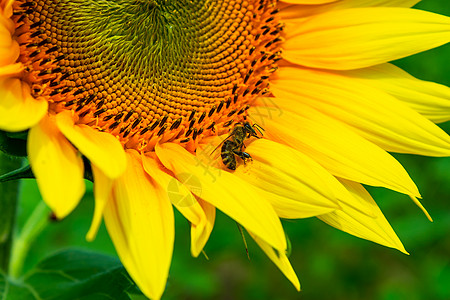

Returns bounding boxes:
[0,0,450,299]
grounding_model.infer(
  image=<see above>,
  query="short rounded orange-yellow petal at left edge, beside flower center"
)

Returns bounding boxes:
[0,78,48,131]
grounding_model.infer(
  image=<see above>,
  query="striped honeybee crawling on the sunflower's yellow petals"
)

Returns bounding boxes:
[211,122,264,171]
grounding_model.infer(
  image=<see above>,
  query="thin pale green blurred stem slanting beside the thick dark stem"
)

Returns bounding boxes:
[9,201,51,278]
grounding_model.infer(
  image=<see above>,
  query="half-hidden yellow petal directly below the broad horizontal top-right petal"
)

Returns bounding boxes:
[339,64,450,123]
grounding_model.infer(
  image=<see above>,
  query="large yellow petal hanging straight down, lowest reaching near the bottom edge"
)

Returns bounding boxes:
[104,150,175,299]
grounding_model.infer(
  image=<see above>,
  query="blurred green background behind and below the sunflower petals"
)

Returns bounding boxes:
[7,0,450,300]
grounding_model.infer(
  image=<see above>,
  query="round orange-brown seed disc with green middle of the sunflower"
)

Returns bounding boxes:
[13,0,282,151]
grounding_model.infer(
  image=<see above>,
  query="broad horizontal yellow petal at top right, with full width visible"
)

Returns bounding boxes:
[283,7,450,70]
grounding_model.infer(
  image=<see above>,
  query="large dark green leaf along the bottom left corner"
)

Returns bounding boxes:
[0,249,143,300]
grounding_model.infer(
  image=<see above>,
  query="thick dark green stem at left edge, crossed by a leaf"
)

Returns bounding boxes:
[0,152,22,273]
